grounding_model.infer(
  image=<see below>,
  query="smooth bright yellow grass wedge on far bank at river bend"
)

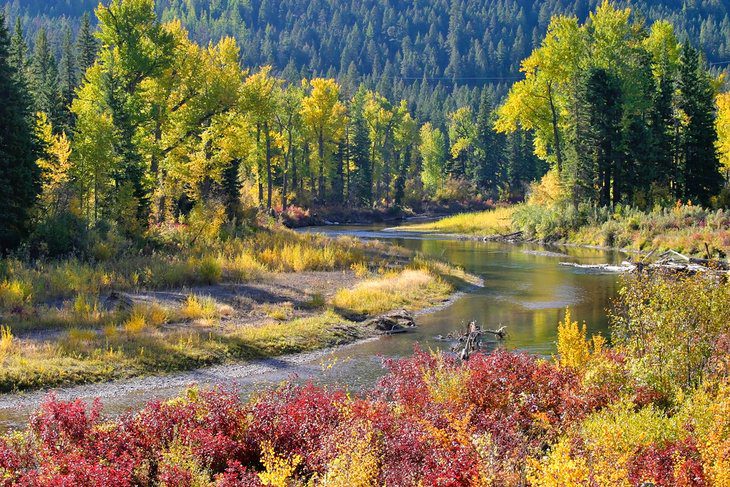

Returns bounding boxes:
[401,207,514,235]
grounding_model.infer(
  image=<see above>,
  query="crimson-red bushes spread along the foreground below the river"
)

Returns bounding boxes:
[0,350,704,487]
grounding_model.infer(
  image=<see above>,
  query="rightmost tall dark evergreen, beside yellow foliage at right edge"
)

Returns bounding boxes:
[679,43,722,204]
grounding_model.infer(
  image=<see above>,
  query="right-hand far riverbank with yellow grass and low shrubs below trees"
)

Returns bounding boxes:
[399,204,730,258]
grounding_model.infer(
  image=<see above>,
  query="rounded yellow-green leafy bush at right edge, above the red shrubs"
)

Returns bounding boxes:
[611,272,730,394]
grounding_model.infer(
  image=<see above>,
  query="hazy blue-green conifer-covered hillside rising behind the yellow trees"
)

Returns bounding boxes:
[4,0,730,123]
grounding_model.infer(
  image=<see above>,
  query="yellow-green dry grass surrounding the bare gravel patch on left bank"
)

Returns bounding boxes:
[0,225,474,392]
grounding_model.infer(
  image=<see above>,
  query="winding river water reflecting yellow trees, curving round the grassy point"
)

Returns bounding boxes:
[0,226,622,430]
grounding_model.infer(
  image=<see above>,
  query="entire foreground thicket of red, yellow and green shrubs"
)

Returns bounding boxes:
[0,275,730,486]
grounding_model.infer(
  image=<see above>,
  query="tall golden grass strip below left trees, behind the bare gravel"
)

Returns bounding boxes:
[0,230,367,311]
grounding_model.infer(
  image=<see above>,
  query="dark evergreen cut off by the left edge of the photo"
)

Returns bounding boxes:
[0,12,40,252]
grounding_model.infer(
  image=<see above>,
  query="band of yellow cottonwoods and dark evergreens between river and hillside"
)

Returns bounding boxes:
[0,0,727,254]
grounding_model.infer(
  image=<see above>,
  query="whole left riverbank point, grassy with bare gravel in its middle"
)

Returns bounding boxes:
[0,227,474,392]
